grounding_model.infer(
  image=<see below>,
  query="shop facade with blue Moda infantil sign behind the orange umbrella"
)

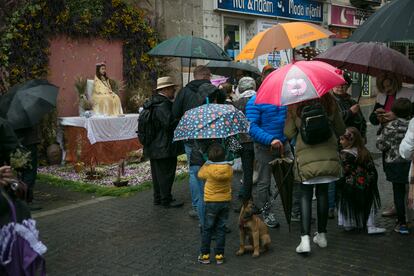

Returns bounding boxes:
[204,0,328,70]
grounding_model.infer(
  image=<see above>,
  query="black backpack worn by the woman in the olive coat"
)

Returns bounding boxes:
[300,102,332,145]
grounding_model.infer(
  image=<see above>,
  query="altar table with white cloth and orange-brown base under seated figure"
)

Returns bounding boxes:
[59,114,142,164]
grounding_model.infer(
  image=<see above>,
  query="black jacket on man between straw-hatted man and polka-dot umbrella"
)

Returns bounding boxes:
[172,80,210,120]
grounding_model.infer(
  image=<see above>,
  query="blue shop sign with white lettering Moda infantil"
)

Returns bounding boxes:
[216,0,323,22]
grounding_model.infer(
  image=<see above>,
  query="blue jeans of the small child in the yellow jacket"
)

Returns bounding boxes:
[200,202,230,255]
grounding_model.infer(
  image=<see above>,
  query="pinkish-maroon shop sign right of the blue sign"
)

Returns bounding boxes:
[330,5,372,28]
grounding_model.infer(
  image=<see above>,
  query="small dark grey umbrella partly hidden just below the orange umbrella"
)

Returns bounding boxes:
[206,61,261,77]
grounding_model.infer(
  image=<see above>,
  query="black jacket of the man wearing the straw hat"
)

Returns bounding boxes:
[144,94,183,159]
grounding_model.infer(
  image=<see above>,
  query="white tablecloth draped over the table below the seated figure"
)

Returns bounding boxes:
[59,114,138,144]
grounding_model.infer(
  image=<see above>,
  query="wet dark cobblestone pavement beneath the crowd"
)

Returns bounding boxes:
[38,113,414,275]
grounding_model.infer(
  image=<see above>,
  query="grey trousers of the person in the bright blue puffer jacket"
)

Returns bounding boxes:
[253,143,292,209]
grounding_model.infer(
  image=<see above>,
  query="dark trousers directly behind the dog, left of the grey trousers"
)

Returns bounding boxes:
[239,142,254,201]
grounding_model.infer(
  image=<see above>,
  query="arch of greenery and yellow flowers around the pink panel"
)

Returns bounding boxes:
[0,0,157,91]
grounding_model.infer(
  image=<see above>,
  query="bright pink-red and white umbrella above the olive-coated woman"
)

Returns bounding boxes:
[255,61,345,106]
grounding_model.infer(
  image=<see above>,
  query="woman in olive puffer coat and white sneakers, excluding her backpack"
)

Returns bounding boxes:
[284,94,345,253]
